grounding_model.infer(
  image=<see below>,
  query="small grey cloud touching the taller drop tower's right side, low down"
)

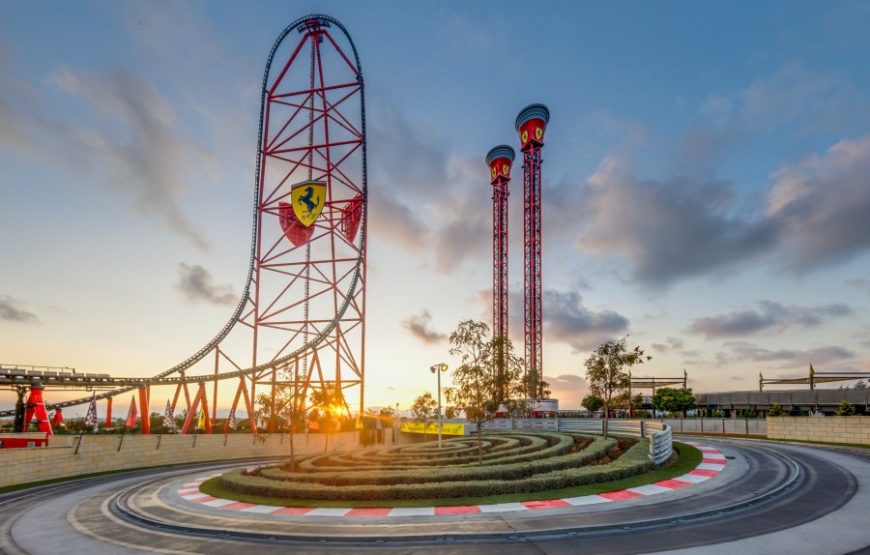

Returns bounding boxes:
[540,290,628,351]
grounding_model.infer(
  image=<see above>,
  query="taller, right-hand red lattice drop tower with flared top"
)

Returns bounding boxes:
[516,104,550,399]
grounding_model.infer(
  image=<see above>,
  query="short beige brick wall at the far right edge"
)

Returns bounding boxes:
[767,416,870,445]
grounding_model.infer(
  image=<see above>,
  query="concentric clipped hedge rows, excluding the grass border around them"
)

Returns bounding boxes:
[221,432,651,501]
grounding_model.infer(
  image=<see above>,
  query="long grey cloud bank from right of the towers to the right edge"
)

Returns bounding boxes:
[576,128,870,288]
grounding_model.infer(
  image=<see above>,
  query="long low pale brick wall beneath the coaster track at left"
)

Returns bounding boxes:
[0,432,362,487]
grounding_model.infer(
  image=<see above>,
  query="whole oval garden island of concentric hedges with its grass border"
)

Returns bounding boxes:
[202,432,700,506]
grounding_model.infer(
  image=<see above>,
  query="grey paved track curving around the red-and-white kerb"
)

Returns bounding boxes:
[0,438,870,555]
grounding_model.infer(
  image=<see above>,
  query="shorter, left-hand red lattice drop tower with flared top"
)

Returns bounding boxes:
[486,145,515,399]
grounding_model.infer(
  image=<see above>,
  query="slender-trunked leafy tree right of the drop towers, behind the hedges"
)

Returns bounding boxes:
[586,337,652,437]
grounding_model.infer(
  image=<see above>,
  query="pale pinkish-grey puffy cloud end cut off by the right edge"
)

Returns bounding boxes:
[767,135,870,274]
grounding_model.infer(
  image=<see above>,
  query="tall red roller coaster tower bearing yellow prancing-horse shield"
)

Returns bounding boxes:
[240,15,366,429]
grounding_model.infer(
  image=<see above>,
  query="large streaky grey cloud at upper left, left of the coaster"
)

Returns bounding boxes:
[0,54,212,249]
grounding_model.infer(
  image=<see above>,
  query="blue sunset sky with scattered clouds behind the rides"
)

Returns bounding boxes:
[0,1,870,414]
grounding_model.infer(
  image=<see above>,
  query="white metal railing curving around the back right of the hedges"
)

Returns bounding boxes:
[483,418,674,466]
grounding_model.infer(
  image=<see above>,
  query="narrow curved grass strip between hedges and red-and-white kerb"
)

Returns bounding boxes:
[200,441,702,508]
